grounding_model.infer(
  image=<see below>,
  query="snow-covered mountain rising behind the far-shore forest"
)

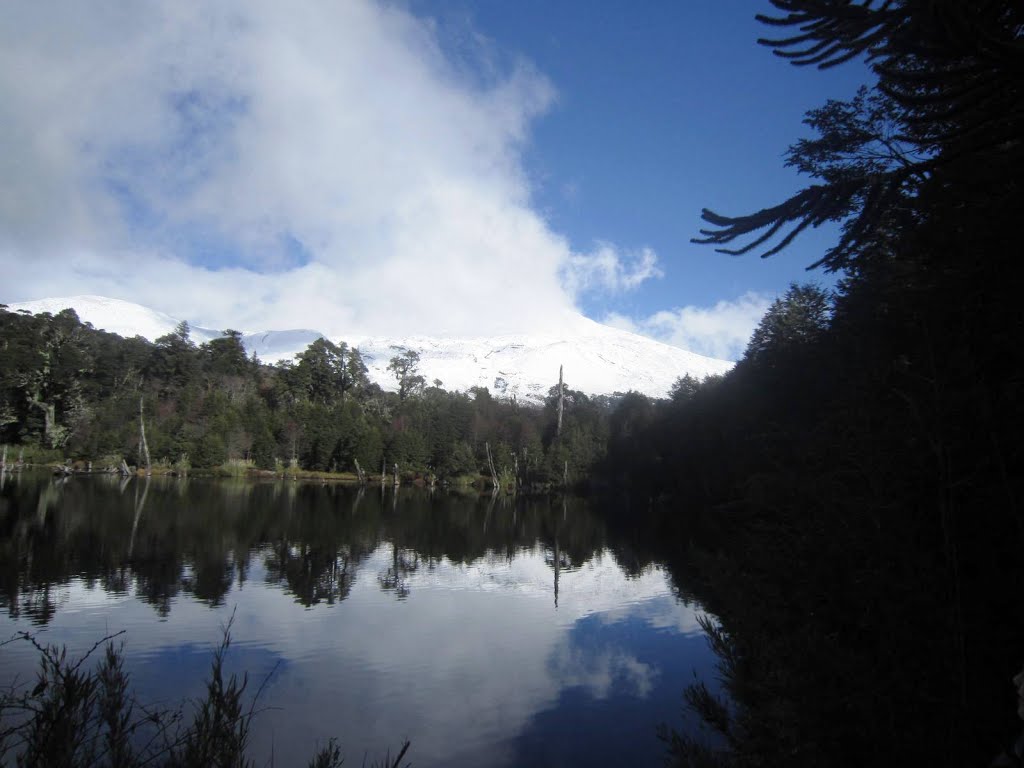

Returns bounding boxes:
[9,296,733,402]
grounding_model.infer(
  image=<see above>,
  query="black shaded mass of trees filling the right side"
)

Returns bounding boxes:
[622,0,1024,766]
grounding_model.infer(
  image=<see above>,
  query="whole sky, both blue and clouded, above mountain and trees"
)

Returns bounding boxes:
[0,0,867,359]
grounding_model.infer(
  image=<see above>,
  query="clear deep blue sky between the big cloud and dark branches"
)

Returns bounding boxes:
[432,0,868,316]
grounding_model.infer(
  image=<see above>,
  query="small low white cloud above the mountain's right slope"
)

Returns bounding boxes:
[604,292,771,360]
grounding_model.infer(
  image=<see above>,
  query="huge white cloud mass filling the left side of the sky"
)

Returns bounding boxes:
[0,0,659,334]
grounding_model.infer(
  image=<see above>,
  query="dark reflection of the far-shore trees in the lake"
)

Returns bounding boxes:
[0,473,650,626]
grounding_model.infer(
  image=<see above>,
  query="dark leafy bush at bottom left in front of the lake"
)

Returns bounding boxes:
[0,626,409,768]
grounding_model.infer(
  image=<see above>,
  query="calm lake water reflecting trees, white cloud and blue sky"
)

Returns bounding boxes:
[0,474,714,768]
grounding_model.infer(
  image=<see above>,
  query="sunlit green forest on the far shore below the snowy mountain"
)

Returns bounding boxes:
[0,307,614,490]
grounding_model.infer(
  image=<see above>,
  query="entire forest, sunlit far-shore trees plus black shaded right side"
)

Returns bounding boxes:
[0,0,1024,766]
